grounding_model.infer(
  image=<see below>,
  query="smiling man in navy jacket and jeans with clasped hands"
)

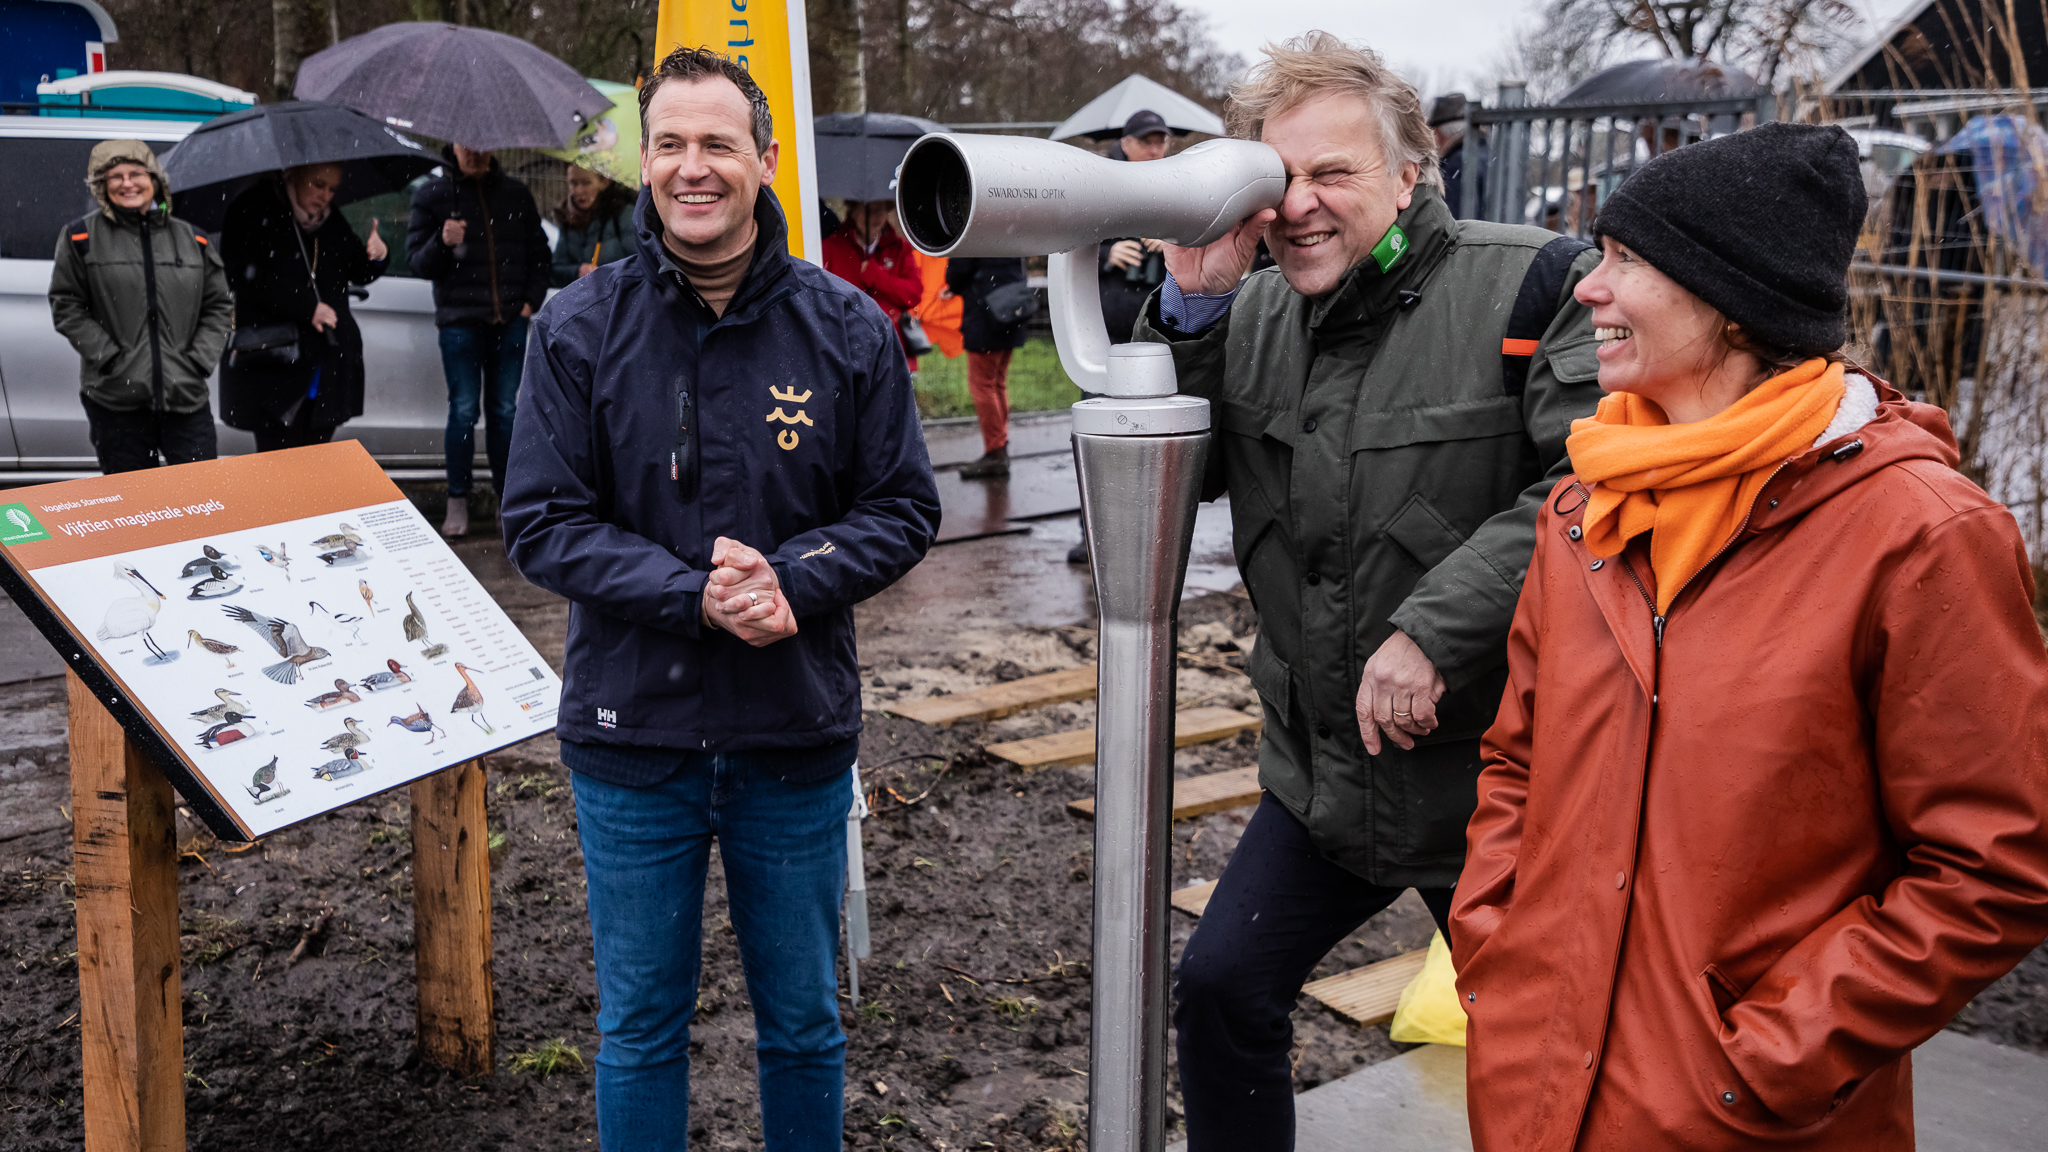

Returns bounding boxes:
[504,49,938,1152]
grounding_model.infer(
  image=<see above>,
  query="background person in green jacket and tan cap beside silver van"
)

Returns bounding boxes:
[49,139,233,474]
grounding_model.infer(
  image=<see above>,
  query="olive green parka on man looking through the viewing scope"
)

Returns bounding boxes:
[1137,187,1599,888]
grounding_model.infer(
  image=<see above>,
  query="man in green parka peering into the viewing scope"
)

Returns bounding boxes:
[1137,33,1599,1152]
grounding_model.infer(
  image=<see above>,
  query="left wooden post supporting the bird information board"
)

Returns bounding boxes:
[66,674,184,1152]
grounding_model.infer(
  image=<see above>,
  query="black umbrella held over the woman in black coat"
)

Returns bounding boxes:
[164,100,440,232]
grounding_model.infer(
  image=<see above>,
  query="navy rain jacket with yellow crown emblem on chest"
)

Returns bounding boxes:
[502,189,938,752]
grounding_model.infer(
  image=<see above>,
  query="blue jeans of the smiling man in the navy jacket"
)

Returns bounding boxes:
[573,752,852,1152]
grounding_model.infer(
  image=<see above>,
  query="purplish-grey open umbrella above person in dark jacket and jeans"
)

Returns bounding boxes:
[293,23,612,152]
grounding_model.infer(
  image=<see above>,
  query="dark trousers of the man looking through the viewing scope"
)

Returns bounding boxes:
[1174,793,1450,1152]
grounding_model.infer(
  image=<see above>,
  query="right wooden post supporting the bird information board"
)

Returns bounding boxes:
[412,760,498,1076]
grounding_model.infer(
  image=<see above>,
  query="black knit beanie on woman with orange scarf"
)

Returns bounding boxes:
[1593,123,1868,357]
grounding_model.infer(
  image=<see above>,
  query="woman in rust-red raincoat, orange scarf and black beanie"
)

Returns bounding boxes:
[1450,125,2048,1152]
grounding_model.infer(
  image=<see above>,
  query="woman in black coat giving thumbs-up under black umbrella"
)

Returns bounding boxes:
[221,164,387,451]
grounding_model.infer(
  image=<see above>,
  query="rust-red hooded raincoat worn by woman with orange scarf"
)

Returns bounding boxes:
[1452,385,2048,1152]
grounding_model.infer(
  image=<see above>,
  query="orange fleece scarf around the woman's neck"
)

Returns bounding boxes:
[1565,357,1845,615]
